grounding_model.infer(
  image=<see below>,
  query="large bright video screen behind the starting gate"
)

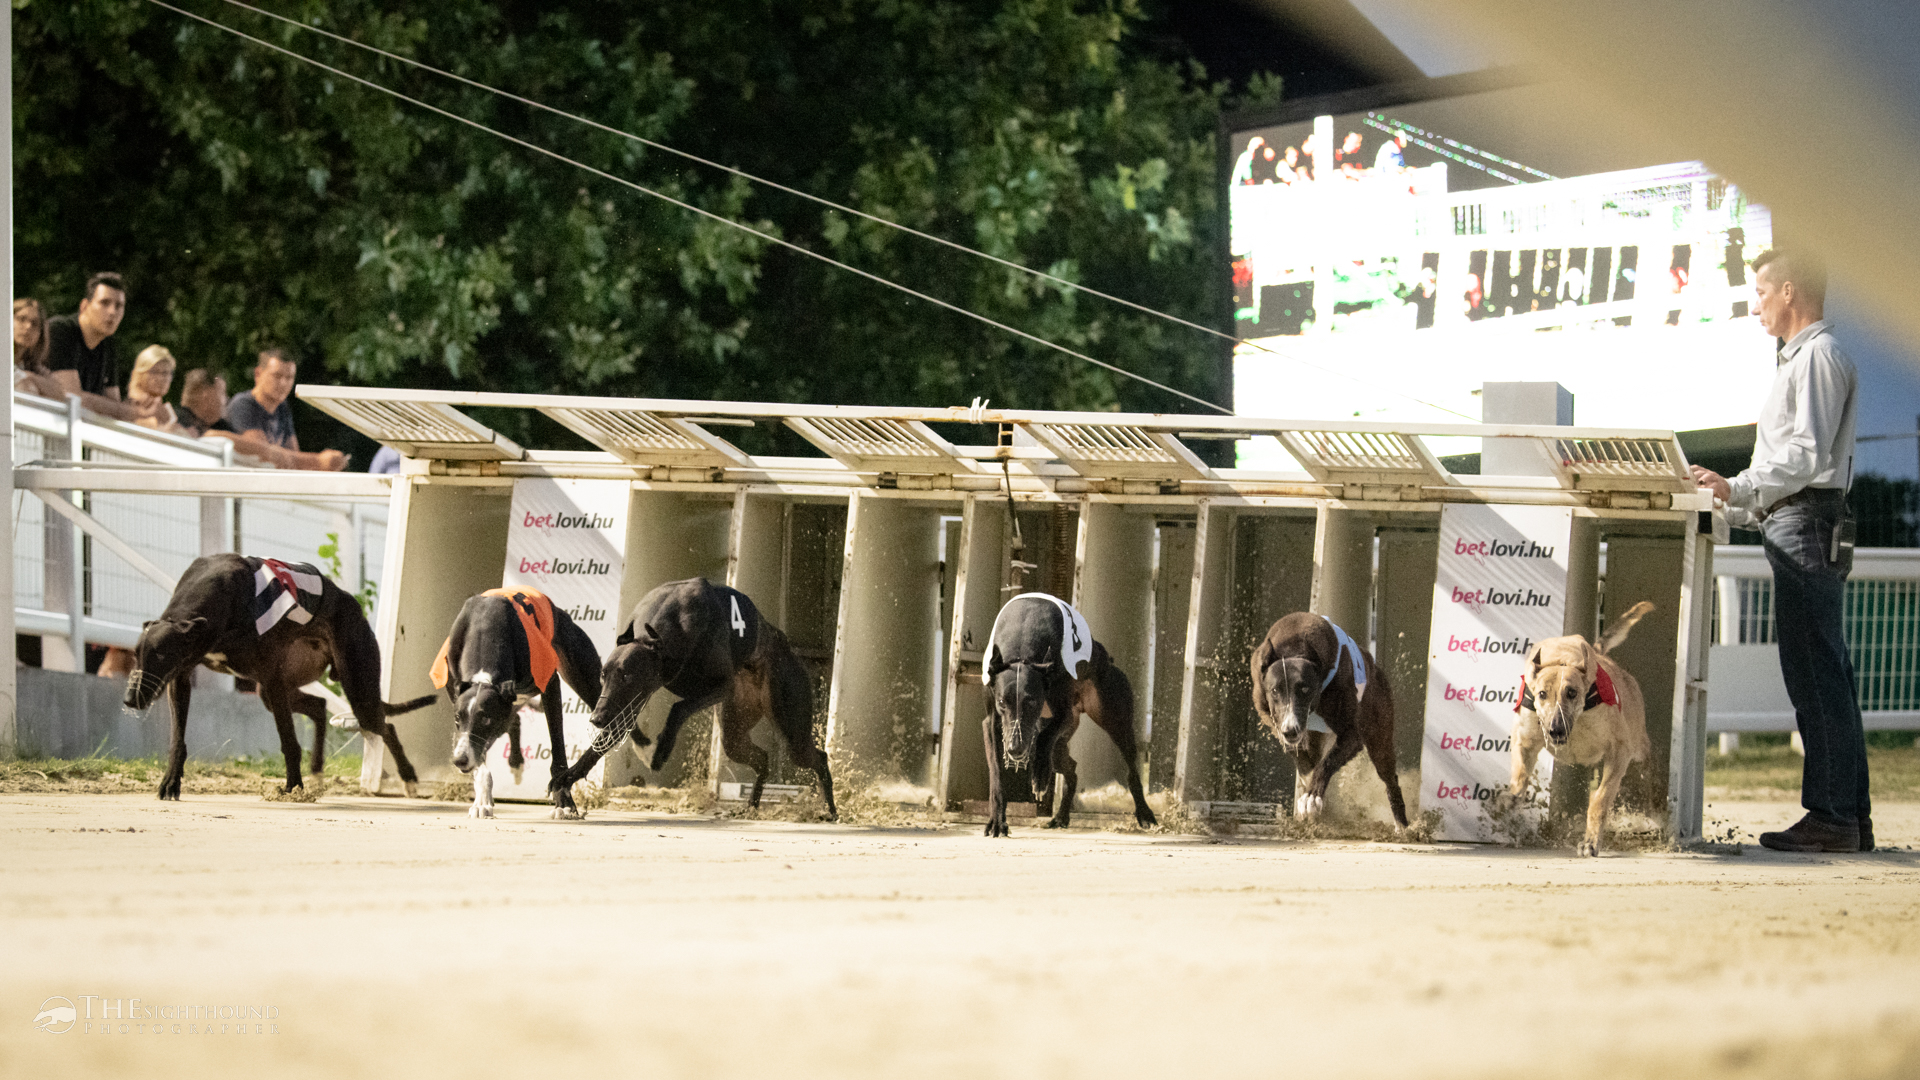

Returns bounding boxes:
[1229,76,1774,469]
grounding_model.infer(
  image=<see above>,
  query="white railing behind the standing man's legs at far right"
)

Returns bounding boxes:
[1707,546,1920,732]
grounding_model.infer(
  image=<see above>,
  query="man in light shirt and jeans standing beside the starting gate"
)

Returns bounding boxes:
[1693,250,1874,851]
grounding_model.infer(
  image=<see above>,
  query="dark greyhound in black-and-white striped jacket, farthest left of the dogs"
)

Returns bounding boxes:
[123,555,434,799]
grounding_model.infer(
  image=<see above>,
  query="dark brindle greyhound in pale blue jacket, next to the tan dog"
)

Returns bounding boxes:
[1252,611,1407,828]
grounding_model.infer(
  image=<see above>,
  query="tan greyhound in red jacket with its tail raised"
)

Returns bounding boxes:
[1505,600,1653,855]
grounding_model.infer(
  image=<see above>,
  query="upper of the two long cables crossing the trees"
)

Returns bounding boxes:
[191,0,1466,423]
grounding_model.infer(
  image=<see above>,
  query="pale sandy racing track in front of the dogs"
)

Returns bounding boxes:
[0,796,1920,1080]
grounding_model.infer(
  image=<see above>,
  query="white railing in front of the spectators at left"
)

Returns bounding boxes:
[12,394,386,657]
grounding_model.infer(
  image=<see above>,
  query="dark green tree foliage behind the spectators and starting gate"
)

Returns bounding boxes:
[13,0,1227,445]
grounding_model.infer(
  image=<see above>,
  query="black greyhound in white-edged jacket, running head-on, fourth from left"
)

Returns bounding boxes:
[981,592,1156,836]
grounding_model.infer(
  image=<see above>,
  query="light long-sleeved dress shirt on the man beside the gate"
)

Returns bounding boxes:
[1726,319,1860,513]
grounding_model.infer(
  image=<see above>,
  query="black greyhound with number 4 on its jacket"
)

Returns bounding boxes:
[552,578,839,821]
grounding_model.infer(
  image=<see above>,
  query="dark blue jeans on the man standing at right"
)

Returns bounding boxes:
[1763,492,1872,826]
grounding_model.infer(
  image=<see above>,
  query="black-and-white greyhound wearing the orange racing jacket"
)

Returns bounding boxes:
[432,588,599,819]
